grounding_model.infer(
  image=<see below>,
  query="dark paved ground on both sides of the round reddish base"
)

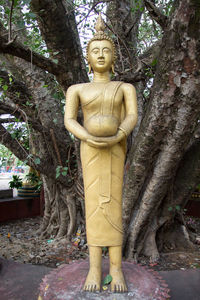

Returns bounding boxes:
[0,258,200,300]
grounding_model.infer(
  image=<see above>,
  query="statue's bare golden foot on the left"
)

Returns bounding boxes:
[83,268,101,292]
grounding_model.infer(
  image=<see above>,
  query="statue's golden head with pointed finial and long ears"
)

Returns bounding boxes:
[86,14,116,73]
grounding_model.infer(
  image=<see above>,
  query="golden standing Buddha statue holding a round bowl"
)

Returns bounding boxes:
[65,12,137,292]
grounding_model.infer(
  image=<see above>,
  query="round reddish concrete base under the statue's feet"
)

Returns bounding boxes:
[38,260,169,300]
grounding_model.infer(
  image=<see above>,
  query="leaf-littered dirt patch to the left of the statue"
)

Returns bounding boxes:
[0,217,88,267]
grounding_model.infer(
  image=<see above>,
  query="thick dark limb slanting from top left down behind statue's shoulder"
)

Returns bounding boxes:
[30,0,88,86]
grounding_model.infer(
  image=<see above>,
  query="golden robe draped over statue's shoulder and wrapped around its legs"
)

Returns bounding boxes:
[81,82,126,247]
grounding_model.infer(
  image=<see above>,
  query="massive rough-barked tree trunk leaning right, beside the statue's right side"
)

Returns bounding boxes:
[124,1,200,260]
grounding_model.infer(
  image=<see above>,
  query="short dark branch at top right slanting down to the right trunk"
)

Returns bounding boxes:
[144,0,168,30]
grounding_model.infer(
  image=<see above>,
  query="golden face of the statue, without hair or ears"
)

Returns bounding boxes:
[88,40,113,73]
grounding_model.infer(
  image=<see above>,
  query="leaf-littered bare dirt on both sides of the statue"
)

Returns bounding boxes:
[0,217,200,271]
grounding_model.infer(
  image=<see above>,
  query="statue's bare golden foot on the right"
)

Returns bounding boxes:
[110,269,128,293]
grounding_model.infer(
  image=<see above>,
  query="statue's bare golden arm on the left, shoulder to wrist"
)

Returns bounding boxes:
[64,85,91,141]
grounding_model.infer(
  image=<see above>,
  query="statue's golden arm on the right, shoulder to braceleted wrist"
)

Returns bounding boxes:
[119,83,138,136]
